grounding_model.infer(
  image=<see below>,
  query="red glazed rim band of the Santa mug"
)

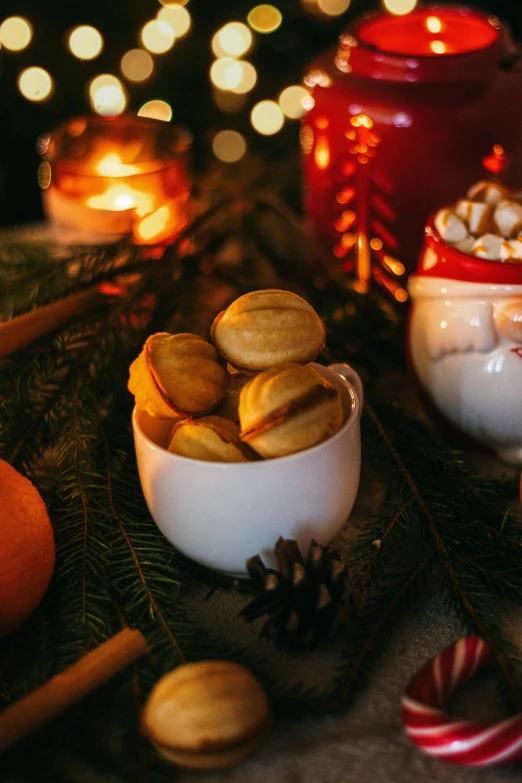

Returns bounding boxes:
[417,215,522,285]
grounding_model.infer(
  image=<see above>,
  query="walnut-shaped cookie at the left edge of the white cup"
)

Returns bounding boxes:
[128,332,230,419]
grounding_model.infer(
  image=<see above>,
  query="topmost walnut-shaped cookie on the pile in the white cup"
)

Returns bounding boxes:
[210,289,326,372]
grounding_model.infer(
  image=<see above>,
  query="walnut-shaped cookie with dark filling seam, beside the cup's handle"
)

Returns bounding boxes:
[239,363,343,459]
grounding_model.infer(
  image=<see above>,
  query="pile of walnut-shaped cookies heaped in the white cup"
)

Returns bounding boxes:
[129,289,343,462]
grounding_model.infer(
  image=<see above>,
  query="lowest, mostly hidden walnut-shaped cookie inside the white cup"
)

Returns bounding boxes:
[168,416,249,462]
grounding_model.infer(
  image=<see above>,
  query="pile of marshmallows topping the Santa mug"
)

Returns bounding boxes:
[434,180,522,262]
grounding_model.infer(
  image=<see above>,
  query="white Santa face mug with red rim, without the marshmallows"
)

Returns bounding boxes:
[408,217,522,465]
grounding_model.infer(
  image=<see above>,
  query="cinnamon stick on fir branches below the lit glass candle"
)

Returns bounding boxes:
[0,286,108,358]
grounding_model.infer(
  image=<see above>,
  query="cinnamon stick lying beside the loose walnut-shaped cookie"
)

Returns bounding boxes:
[0,628,148,753]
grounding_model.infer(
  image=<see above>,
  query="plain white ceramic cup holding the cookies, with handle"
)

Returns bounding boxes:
[132,364,363,577]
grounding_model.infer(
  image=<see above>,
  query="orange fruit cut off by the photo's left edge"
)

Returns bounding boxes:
[0,460,55,638]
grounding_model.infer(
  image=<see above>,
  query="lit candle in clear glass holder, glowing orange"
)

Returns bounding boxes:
[39,115,192,244]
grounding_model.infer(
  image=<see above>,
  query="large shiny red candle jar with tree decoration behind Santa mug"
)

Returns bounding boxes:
[301,6,522,300]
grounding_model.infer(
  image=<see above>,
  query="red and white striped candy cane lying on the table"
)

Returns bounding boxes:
[402,636,522,767]
